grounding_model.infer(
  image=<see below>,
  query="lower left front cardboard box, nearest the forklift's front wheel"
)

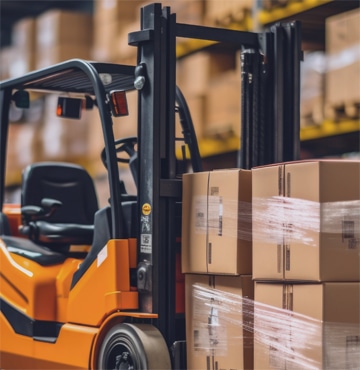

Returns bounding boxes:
[185,275,254,370]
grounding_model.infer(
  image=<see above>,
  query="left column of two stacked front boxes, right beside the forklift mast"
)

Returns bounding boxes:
[182,169,253,370]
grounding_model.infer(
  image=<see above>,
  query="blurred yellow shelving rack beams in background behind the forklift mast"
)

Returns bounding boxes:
[176,0,360,157]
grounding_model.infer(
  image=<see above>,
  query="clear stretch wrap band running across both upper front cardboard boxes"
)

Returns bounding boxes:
[196,196,360,249]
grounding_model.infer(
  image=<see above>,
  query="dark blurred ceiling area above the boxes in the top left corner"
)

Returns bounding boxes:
[0,0,93,48]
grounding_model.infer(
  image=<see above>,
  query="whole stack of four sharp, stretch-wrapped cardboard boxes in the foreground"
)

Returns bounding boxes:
[182,160,360,369]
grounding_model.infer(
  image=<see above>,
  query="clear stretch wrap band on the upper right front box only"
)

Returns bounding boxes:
[252,196,360,249]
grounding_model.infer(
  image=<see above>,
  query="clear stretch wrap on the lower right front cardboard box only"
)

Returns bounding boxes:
[254,302,360,370]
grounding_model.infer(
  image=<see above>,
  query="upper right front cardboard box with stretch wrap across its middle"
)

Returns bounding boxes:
[252,160,360,281]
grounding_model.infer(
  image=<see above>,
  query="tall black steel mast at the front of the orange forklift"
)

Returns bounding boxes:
[128,4,302,362]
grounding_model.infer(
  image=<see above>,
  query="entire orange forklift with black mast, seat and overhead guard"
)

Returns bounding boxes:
[0,3,301,370]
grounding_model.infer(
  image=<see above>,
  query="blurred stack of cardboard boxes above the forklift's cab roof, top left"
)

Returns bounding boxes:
[2,9,93,78]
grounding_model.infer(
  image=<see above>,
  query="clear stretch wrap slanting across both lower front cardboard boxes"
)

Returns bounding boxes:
[192,283,360,370]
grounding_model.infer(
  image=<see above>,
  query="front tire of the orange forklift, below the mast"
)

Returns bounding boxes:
[97,324,171,370]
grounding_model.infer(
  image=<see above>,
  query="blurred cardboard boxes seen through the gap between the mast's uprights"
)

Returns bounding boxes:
[176,50,241,139]
